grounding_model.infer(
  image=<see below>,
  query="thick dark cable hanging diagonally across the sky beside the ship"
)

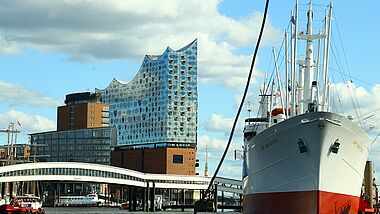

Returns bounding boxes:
[194,0,269,213]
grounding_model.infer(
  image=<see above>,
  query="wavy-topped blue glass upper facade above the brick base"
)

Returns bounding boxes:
[96,40,198,145]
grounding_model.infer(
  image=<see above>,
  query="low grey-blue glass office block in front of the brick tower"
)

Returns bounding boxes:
[30,127,116,165]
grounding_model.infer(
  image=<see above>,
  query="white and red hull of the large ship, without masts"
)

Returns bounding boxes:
[244,112,371,214]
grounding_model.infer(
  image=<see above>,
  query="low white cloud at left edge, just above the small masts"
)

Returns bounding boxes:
[0,109,56,134]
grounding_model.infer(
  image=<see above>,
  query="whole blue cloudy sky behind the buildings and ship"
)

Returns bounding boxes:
[0,0,380,178]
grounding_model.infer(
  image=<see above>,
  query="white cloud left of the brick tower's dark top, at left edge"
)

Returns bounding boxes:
[0,81,61,107]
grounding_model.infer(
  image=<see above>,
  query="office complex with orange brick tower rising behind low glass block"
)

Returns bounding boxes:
[29,92,116,165]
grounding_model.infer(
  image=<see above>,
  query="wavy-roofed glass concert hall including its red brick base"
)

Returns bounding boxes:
[96,40,198,175]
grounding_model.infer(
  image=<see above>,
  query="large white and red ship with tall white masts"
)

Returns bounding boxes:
[243,1,372,214]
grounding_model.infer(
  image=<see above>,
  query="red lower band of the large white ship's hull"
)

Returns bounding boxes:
[243,190,360,214]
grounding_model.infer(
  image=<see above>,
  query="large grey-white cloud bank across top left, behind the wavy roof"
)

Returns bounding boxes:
[0,0,280,89]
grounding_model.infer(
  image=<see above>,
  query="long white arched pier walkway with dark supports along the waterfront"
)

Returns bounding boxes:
[0,162,242,211]
